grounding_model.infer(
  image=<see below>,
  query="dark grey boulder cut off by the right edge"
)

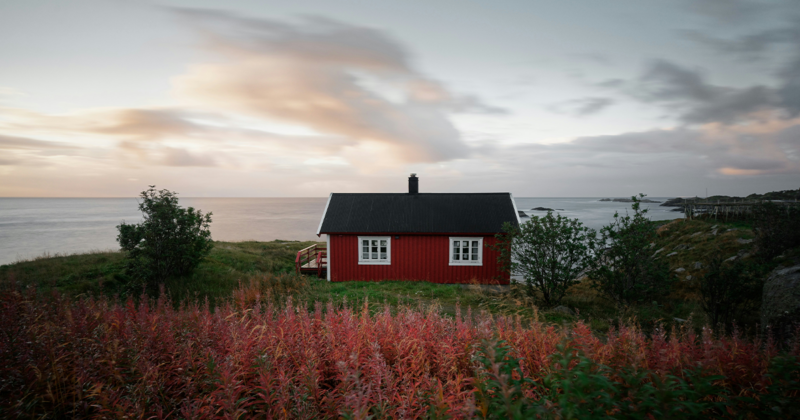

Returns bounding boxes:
[761,264,800,339]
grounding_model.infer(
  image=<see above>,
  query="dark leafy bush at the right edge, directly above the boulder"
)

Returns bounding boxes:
[753,202,800,260]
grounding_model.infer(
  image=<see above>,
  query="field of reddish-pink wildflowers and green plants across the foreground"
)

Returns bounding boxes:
[0,278,800,419]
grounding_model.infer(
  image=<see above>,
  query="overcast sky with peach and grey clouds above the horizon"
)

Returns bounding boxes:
[0,0,800,197]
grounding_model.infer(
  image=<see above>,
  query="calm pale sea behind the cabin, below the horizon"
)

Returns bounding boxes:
[0,197,680,264]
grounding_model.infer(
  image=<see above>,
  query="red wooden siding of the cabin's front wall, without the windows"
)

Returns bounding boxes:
[328,234,509,284]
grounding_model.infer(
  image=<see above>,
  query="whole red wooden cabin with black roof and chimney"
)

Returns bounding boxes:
[317,174,519,284]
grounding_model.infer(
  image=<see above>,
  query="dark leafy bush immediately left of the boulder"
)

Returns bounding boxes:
[700,256,763,332]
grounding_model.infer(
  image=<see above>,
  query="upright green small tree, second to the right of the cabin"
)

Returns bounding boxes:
[589,194,672,305]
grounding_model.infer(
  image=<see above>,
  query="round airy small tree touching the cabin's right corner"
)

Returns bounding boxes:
[495,212,596,305]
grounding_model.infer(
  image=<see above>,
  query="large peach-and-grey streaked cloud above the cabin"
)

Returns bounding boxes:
[174,9,503,162]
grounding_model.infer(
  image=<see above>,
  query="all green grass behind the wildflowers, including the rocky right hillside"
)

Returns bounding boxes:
[0,220,780,332]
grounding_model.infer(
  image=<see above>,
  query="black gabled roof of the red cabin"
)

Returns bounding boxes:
[317,193,519,234]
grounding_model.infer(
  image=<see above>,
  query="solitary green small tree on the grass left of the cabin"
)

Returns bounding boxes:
[117,185,214,285]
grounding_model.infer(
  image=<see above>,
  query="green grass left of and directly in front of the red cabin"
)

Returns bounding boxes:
[0,241,533,315]
